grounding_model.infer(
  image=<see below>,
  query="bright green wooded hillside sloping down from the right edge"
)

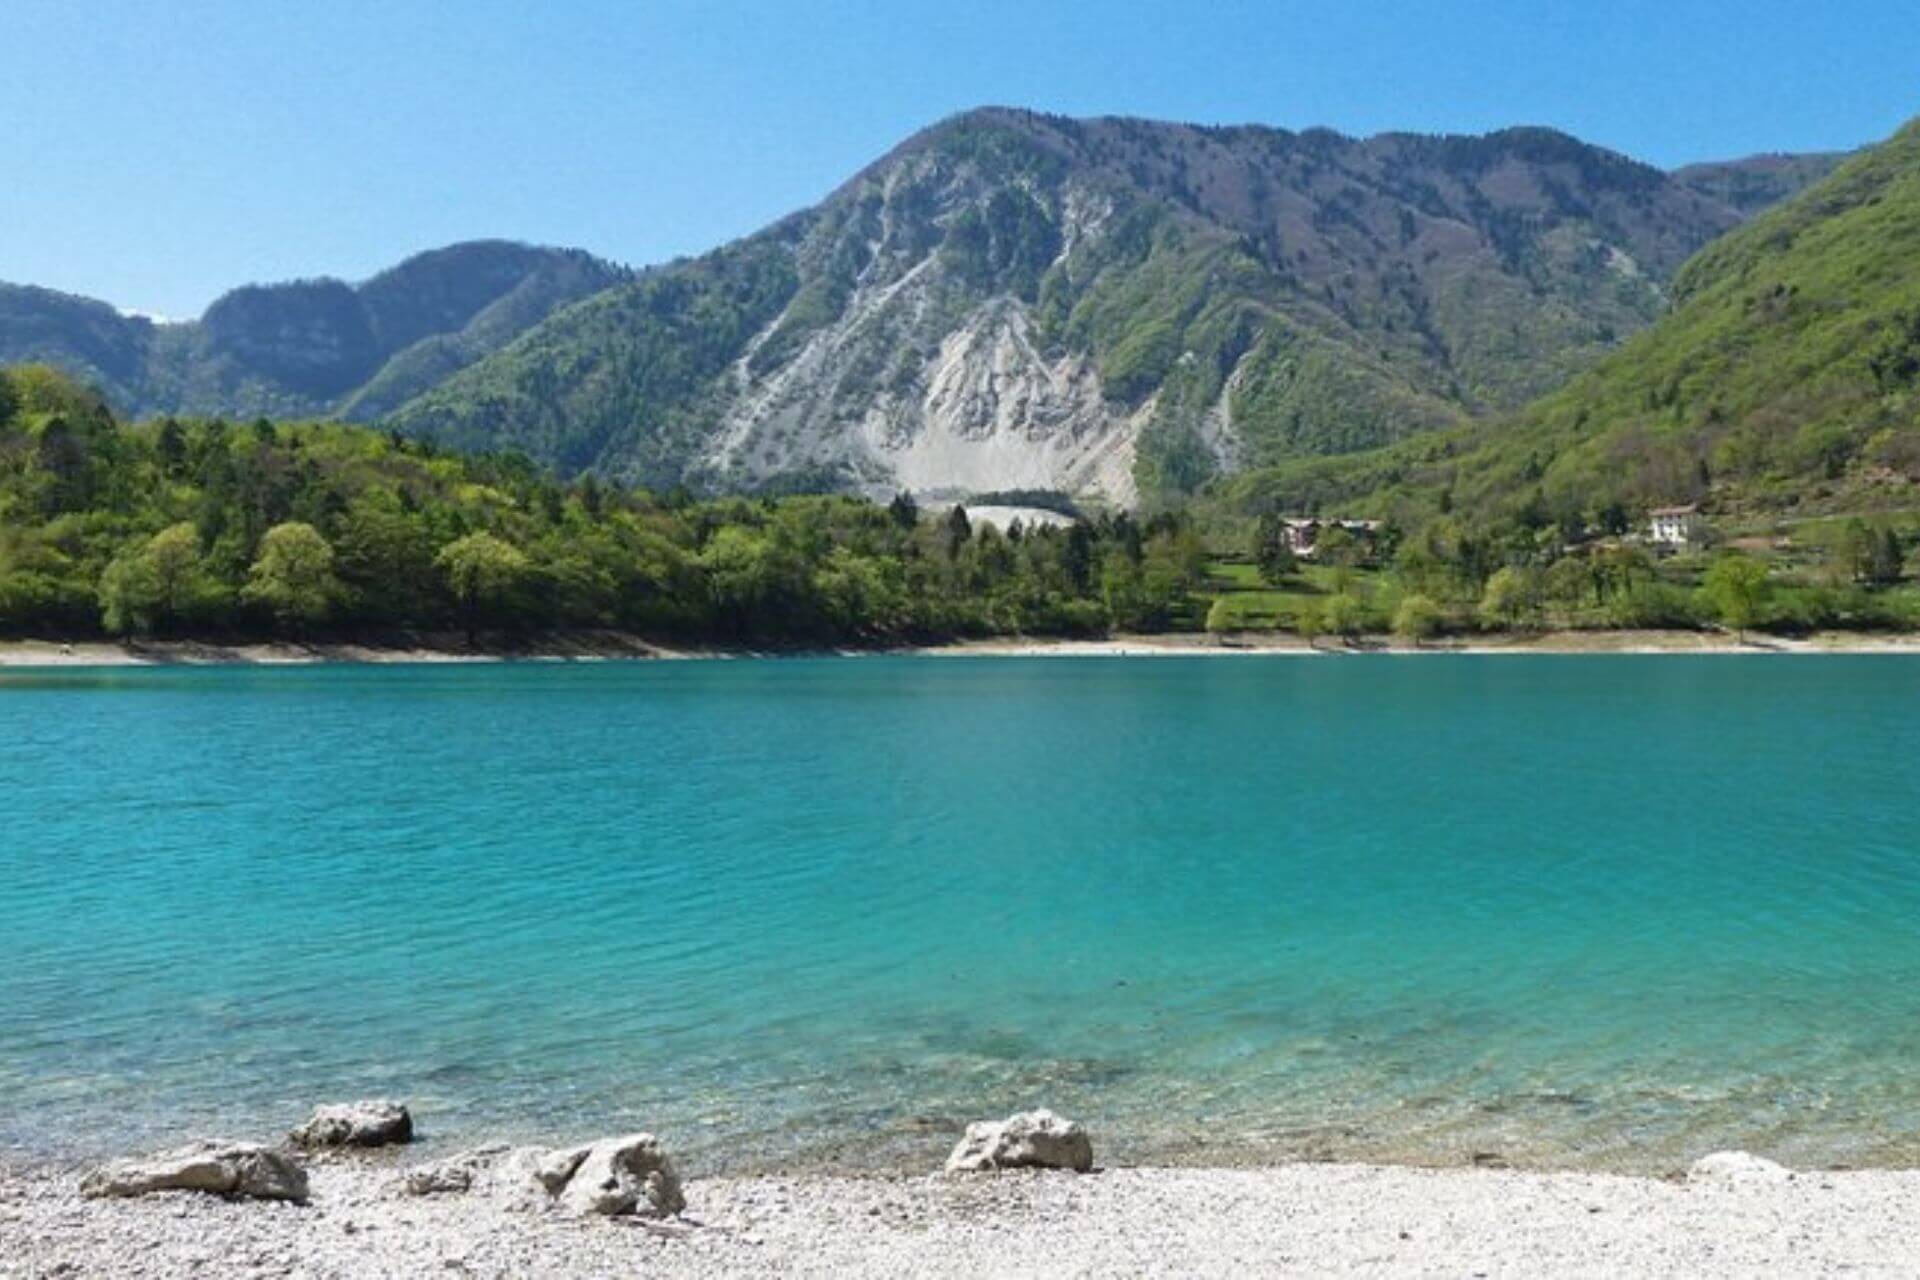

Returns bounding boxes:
[1223,121,1920,526]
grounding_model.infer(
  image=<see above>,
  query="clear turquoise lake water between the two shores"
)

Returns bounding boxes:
[0,656,1920,1171]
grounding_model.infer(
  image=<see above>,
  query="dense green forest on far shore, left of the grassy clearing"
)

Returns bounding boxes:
[0,367,1206,645]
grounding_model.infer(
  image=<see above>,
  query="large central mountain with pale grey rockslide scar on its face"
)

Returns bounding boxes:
[394,109,1818,503]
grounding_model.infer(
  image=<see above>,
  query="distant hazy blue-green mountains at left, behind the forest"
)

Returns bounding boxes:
[0,240,626,429]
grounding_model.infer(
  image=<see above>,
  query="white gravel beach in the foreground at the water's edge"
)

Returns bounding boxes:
[0,1159,1920,1278]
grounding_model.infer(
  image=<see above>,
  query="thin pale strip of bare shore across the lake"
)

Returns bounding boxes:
[0,631,1920,670]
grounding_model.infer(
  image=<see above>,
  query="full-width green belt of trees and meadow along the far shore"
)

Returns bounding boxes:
[0,355,1920,651]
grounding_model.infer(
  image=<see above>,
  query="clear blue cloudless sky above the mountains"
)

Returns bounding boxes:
[0,0,1920,317]
